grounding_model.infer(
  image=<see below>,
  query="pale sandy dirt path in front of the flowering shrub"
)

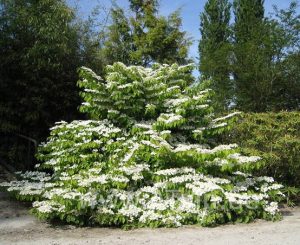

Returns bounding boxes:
[0,193,300,245]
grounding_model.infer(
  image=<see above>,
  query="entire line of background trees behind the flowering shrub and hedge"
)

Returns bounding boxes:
[0,0,300,168]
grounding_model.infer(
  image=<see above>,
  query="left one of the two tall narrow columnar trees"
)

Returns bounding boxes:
[199,0,232,111]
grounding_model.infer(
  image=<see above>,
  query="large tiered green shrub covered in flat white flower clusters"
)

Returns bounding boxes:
[1,63,282,227]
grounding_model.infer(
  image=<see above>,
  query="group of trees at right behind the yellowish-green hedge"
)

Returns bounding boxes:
[199,0,300,112]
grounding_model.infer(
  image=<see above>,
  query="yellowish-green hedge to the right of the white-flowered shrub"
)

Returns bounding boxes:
[230,112,300,187]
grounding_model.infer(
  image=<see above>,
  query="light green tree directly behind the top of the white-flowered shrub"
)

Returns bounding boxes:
[104,0,191,66]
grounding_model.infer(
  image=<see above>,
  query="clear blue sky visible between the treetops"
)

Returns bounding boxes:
[67,0,300,68]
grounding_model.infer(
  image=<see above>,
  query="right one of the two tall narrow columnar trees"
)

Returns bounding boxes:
[233,0,273,111]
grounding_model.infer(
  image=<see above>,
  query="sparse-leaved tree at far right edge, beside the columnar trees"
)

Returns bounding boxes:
[273,1,300,110]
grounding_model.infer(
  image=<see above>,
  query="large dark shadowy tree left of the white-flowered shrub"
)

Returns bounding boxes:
[0,0,81,168]
